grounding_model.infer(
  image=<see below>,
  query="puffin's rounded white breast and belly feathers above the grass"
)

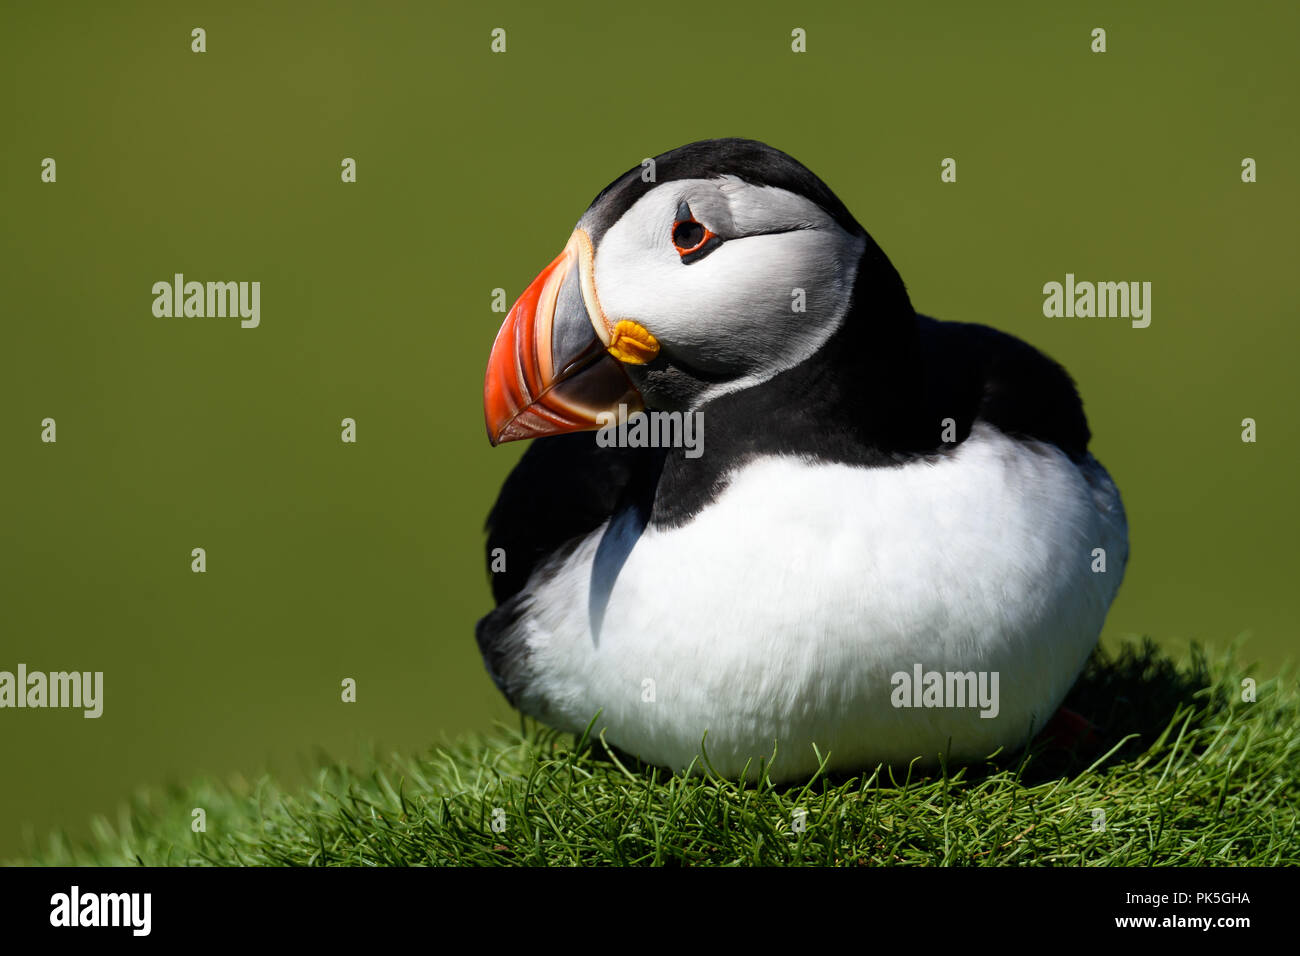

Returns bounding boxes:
[520,425,1128,779]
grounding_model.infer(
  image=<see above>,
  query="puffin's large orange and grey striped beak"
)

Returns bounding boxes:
[484,229,647,445]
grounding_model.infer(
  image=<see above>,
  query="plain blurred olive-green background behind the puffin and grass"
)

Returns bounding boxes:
[0,3,1300,858]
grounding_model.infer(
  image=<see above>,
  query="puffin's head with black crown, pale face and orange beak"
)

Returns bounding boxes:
[484,139,901,445]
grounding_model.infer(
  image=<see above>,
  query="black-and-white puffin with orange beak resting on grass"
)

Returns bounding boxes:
[476,139,1128,783]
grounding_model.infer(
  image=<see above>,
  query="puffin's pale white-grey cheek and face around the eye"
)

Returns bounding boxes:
[579,177,866,401]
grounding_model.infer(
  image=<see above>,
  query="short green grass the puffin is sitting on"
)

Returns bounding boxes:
[18,643,1300,866]
